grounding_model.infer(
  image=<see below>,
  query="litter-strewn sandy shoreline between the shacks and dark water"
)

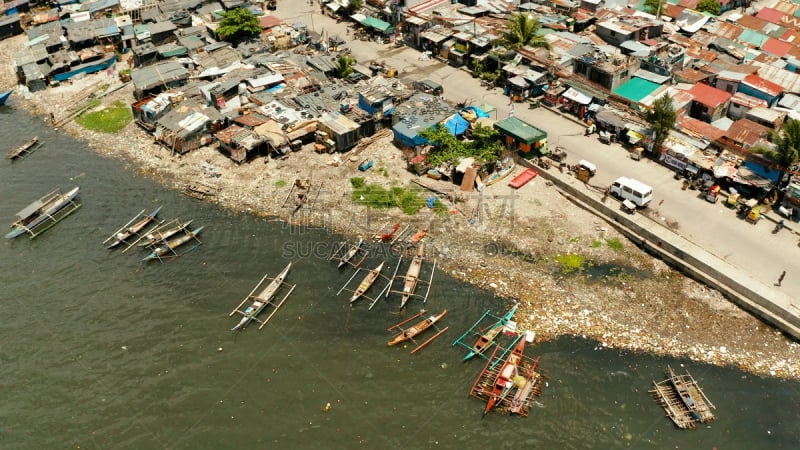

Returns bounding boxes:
[0,36,800,379]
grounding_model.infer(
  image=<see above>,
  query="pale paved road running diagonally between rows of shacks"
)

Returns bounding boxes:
[276,1,800,304]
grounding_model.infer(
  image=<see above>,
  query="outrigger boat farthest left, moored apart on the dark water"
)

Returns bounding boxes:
[6,187,80,239]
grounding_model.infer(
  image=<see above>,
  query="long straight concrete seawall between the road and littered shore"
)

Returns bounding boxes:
[518,159,800,340]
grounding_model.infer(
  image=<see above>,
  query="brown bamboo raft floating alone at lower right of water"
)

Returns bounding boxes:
[650,367,716,430]
